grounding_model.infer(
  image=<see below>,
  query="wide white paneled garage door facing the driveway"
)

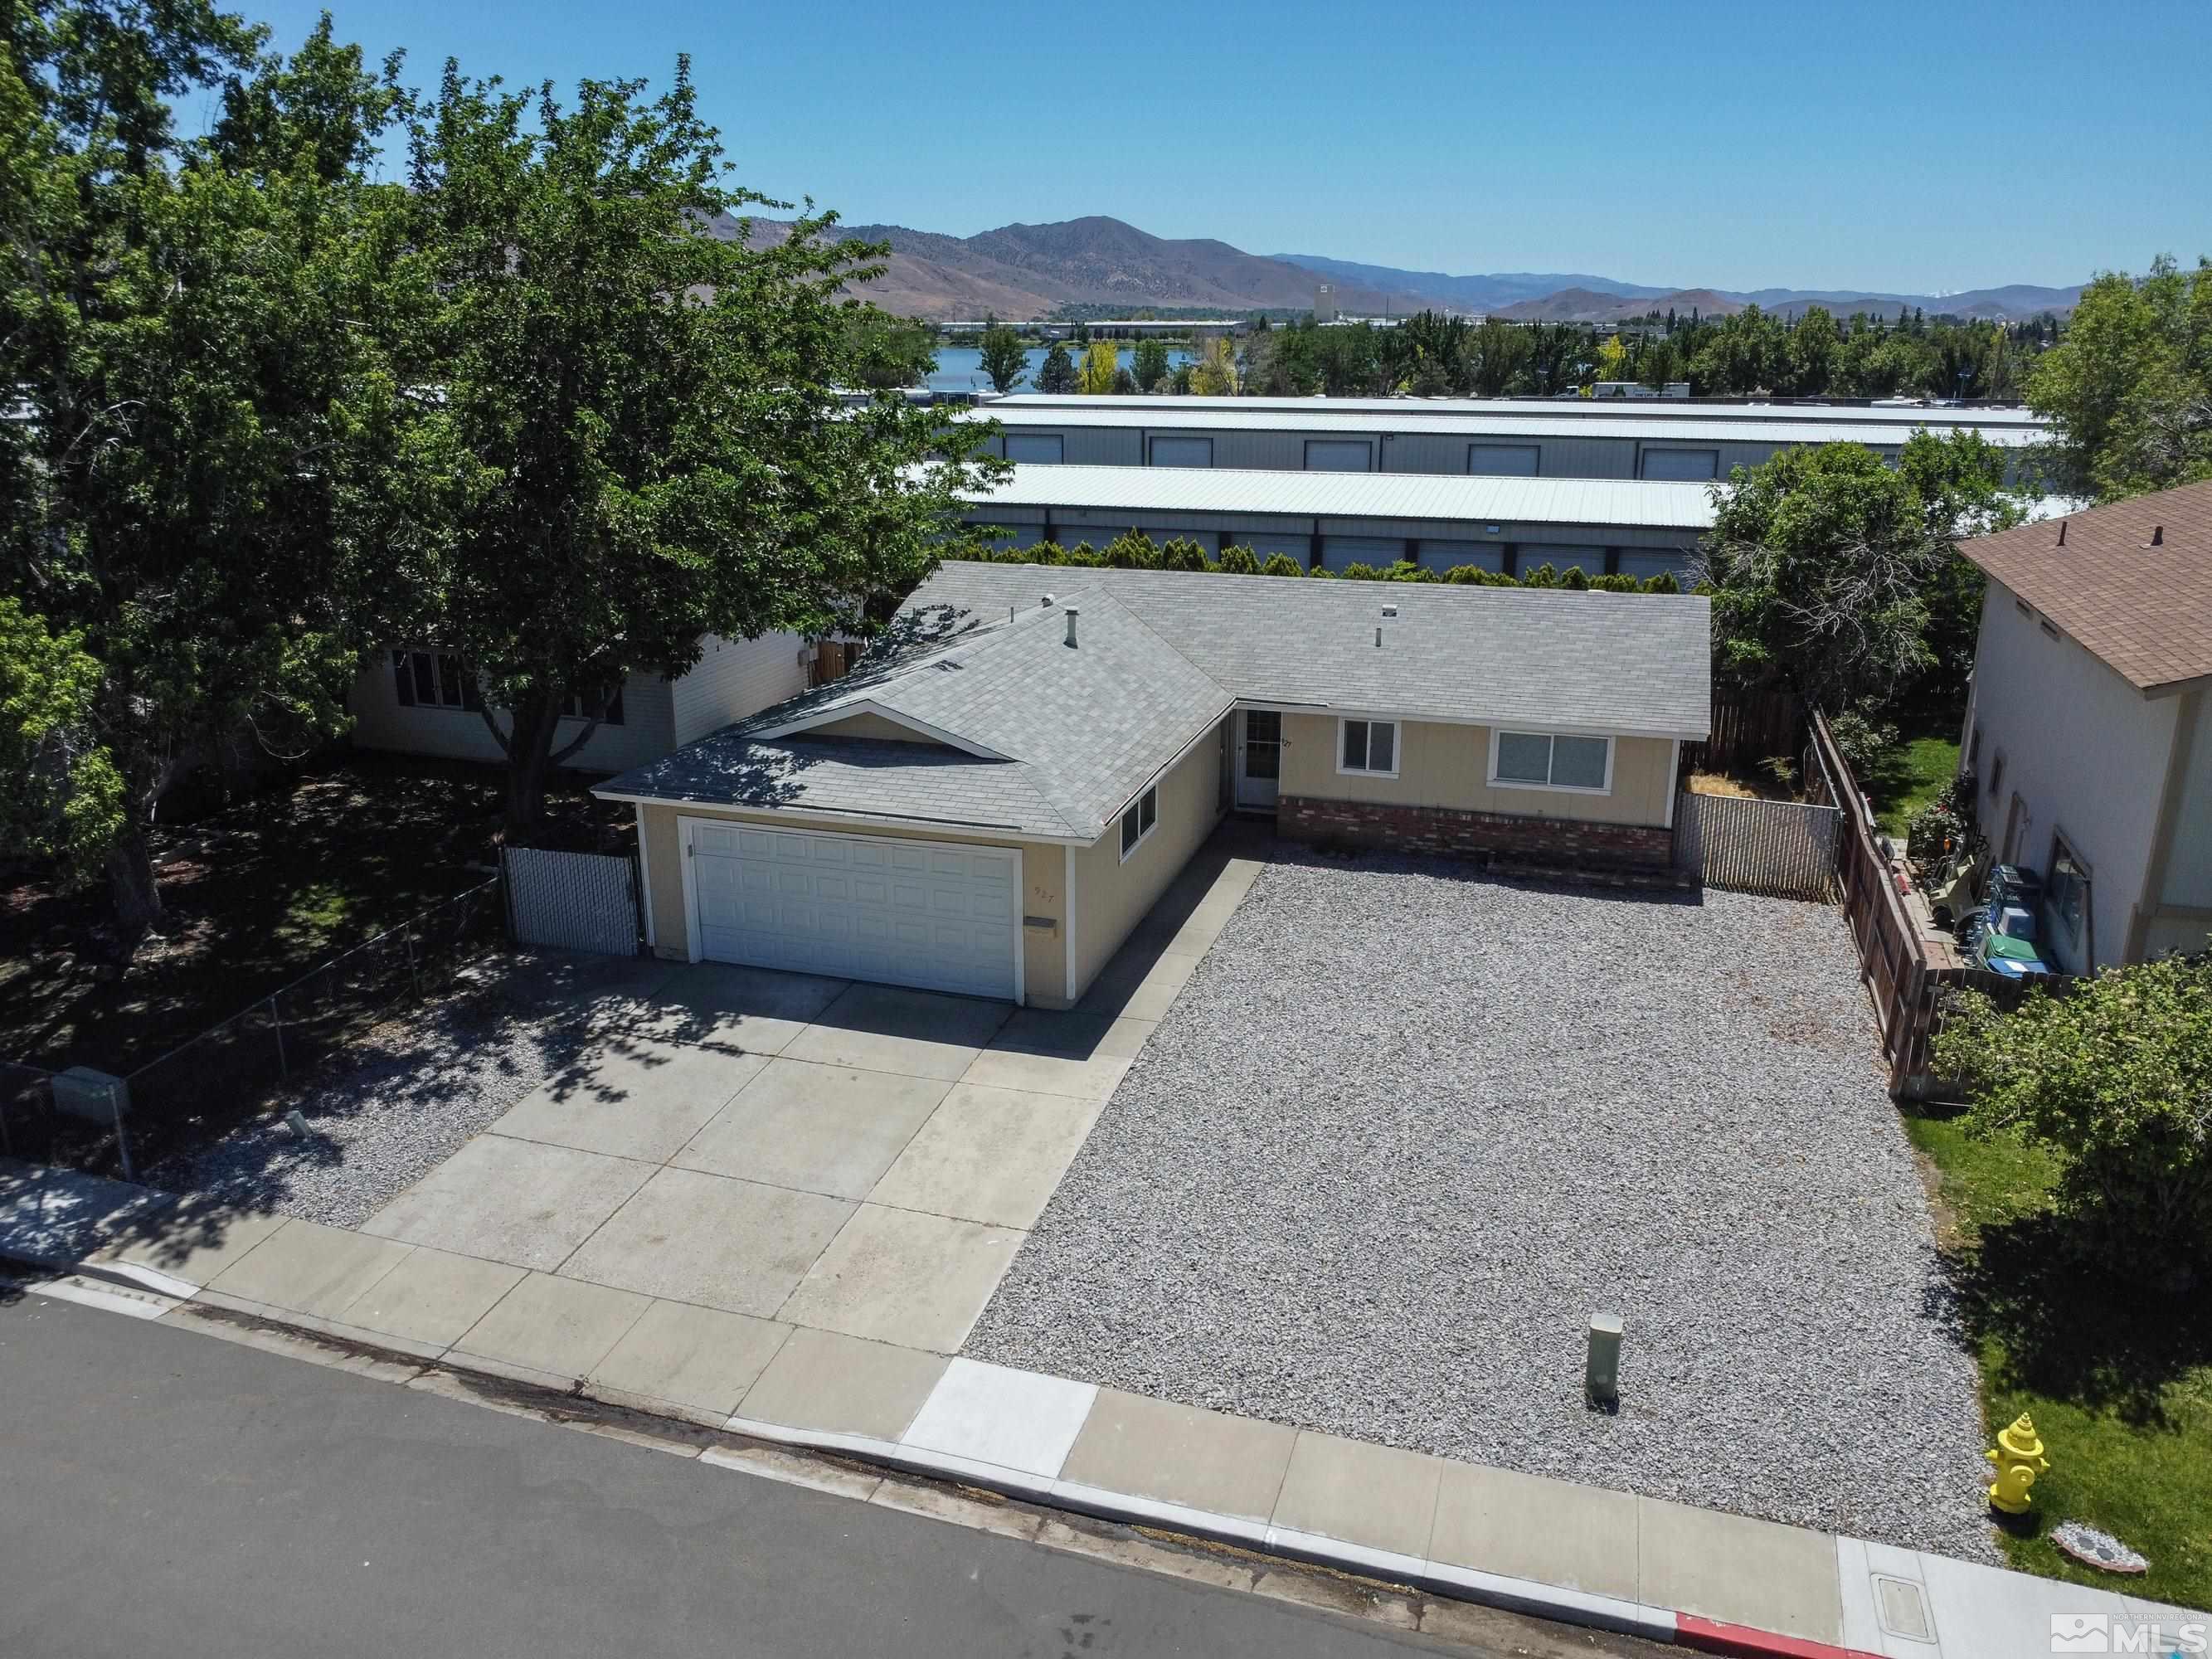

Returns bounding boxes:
[686,819,1022,1000]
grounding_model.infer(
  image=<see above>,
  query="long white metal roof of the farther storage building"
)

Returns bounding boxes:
[960,398,2042,449]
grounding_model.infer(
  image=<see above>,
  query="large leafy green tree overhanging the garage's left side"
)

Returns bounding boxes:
[402,60,999,836]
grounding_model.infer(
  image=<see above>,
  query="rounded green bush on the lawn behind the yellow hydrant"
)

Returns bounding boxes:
[1936,953,2212,1294]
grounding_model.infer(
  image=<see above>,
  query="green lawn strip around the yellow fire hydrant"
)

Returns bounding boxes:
[1904,1112,2212,1608]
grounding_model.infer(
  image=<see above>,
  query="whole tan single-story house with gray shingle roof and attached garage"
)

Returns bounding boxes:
[597,564,1712,1006]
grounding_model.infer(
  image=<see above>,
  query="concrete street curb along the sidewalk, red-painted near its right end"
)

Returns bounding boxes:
[0,1254,1883,1659]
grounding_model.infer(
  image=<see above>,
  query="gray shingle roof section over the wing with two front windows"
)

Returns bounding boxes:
[909,562,1712,739]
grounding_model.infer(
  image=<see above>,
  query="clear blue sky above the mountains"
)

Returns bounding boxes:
[242,0,2212,292]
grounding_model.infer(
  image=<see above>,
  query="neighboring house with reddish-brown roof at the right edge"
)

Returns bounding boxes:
[1960,484,2212,973]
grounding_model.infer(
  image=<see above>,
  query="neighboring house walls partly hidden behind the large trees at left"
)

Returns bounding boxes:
[348,633,816,772]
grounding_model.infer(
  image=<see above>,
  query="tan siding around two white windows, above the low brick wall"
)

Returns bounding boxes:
[1281,714,1675,827]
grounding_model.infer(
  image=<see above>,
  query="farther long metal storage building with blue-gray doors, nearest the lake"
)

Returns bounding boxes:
[973,398,2042,482]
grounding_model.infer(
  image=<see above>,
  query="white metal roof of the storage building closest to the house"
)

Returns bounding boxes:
[969,465,1712,531]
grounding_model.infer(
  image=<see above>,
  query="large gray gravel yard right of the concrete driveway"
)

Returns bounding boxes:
[966,854,1996,1559]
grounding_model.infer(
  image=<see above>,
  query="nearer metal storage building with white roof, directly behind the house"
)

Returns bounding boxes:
[969,465,1712,577]
